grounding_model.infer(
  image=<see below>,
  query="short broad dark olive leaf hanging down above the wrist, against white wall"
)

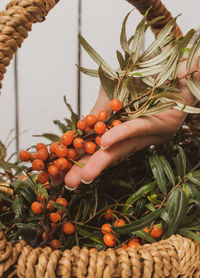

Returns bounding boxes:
[98,66,116,99]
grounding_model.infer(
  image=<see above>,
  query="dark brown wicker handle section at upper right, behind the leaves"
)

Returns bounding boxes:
[127,0,182,38]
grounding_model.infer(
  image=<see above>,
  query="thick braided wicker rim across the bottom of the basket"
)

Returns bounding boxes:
[0,231,200,278]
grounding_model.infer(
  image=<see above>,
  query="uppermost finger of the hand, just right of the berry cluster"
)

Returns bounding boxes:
[101,109,185,149]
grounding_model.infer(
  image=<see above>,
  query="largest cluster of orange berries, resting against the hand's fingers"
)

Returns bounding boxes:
[19,99,122,184]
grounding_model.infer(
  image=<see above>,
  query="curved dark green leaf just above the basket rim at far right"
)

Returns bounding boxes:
[165,189,187,238]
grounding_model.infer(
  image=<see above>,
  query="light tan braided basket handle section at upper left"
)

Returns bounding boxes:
[0,0,56,88]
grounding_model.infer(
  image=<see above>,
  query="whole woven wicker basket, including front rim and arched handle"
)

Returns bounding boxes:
[0,0,200,278]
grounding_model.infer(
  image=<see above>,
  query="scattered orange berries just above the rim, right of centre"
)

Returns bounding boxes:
[101,209,163,249]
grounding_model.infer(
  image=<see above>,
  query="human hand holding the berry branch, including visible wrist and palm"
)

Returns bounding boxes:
[65,50,200,189]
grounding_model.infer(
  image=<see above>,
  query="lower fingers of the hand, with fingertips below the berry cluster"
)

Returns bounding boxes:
[65,136,163,188]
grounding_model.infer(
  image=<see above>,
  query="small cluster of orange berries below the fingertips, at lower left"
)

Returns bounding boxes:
[31,197,75,248]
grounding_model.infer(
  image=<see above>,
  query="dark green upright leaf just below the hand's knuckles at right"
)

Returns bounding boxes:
[149,155,167,195]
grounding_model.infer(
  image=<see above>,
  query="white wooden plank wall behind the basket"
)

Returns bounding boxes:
[0,0,200,157]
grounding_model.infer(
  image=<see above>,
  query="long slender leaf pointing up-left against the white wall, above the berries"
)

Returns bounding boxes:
[78,35,117,78]
